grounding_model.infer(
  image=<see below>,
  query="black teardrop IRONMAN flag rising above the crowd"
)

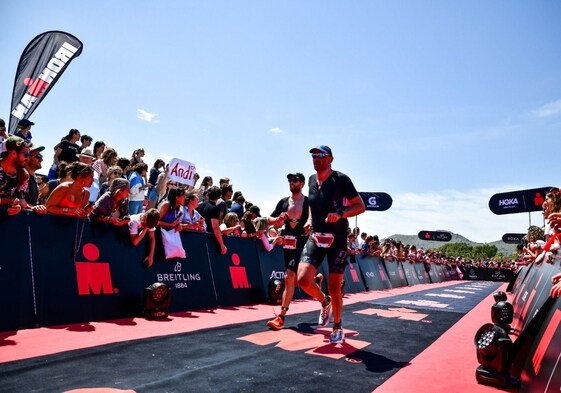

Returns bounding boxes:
[8,31,82,133]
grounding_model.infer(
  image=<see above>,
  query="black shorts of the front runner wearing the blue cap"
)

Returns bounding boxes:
[300,234,347,274]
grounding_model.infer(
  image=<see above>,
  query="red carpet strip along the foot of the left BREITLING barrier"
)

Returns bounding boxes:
[0,281,464,363]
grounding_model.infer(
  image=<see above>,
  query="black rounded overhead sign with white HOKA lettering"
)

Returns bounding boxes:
[489,187,553,214]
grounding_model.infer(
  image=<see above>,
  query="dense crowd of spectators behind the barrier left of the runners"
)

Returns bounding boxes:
[0,119,280,266]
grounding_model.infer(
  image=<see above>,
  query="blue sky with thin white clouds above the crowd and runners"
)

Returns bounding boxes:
[0,0,561,242]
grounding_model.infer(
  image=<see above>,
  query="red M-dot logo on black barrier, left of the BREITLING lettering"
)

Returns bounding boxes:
[75,243,119,295]
